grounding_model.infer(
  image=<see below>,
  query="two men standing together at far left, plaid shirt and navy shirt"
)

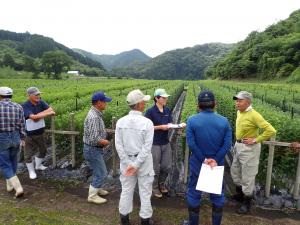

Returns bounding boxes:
[0,87,55,197]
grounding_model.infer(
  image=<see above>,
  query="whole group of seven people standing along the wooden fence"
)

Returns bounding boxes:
[0,84,286,225]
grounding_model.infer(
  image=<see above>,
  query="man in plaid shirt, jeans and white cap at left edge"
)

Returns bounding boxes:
[0,87,25,197]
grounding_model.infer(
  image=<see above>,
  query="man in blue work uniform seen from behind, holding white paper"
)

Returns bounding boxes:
[186,91,232,225]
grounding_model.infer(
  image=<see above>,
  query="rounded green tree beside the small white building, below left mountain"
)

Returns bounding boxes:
[42,51,72,79]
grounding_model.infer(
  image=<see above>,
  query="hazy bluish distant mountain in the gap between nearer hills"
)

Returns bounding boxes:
[73,49,151,70]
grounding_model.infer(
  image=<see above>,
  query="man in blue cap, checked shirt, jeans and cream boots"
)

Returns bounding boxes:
[83,91,112,204]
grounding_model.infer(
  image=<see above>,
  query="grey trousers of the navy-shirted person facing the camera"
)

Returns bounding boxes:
[151,143,172,188]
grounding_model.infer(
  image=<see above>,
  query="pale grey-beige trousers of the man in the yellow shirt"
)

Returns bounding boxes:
[230,143,261,196]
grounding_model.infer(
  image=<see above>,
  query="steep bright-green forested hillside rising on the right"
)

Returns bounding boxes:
[206,10,300,81]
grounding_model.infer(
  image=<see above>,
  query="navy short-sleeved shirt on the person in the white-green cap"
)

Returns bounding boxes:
[145,104,173,145]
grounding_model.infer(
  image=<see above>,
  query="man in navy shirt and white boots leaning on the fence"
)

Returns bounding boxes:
[22,87,55,179]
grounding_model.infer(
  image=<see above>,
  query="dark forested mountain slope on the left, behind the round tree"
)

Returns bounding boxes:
[0,30,105,76]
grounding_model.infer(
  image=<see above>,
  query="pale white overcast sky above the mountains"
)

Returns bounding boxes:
[0,0,300,57]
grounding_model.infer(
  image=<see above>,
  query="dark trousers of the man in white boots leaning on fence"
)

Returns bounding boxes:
[24,134,47,163]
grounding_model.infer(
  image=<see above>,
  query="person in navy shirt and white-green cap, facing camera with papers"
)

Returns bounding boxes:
[145,89,173,198]
